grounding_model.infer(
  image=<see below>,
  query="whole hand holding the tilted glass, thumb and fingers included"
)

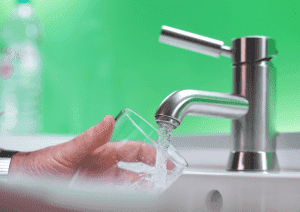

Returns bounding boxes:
[8,116,175,187]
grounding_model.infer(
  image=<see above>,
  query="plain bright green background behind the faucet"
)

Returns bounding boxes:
[0,0,300,135]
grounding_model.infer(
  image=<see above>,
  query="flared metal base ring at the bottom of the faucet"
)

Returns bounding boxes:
[227,151,279,172]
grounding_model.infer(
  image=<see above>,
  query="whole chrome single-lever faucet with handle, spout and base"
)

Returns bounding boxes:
[155,26,279,171]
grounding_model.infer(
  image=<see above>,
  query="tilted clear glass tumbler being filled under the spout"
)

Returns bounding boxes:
[69,108,188,194]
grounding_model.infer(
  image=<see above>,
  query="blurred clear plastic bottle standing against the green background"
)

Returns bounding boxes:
[0,0,43,135]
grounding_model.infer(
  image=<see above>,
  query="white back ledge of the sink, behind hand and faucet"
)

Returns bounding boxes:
[0,133,300,178]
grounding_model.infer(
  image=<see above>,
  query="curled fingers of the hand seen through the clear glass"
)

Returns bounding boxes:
[72,141,175,188]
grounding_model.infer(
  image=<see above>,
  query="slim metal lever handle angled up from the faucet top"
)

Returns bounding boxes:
[159,26,232,57]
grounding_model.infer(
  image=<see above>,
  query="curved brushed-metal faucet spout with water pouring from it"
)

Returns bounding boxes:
[155,90,249,129]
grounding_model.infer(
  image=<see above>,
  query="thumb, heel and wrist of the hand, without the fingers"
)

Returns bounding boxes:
[8,115,115,186]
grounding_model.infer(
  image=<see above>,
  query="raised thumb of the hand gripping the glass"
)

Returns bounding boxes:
[52,115,115,167]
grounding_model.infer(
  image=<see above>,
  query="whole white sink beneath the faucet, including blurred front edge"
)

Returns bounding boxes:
[1,134,300,212]
